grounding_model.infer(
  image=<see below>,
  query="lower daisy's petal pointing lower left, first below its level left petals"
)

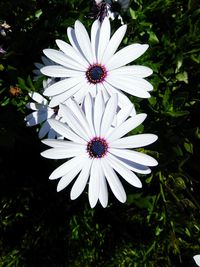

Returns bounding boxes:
[49,155,87,180]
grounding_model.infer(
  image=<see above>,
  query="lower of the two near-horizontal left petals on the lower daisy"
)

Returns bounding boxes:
[41,146,86,159]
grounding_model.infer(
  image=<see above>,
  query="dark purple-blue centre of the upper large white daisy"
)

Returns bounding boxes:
[86,64,107,84]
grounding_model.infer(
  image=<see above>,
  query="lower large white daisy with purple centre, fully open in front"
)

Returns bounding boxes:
[41,92,157,208]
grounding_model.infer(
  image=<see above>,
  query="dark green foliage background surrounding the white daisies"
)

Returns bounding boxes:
[0,0,200,267]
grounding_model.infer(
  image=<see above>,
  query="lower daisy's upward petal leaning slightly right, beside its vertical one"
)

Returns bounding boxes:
[100,94,118,136]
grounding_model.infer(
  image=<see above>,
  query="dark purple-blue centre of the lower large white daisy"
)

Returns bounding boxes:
[87,137,108,158]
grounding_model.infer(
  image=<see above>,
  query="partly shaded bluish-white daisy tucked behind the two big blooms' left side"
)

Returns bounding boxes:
[25,92,62,138]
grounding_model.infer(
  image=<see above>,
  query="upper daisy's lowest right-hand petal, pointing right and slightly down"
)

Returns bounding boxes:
[106,76,152,98]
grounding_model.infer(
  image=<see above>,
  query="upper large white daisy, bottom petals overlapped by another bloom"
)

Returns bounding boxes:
[41,18,153,107]
